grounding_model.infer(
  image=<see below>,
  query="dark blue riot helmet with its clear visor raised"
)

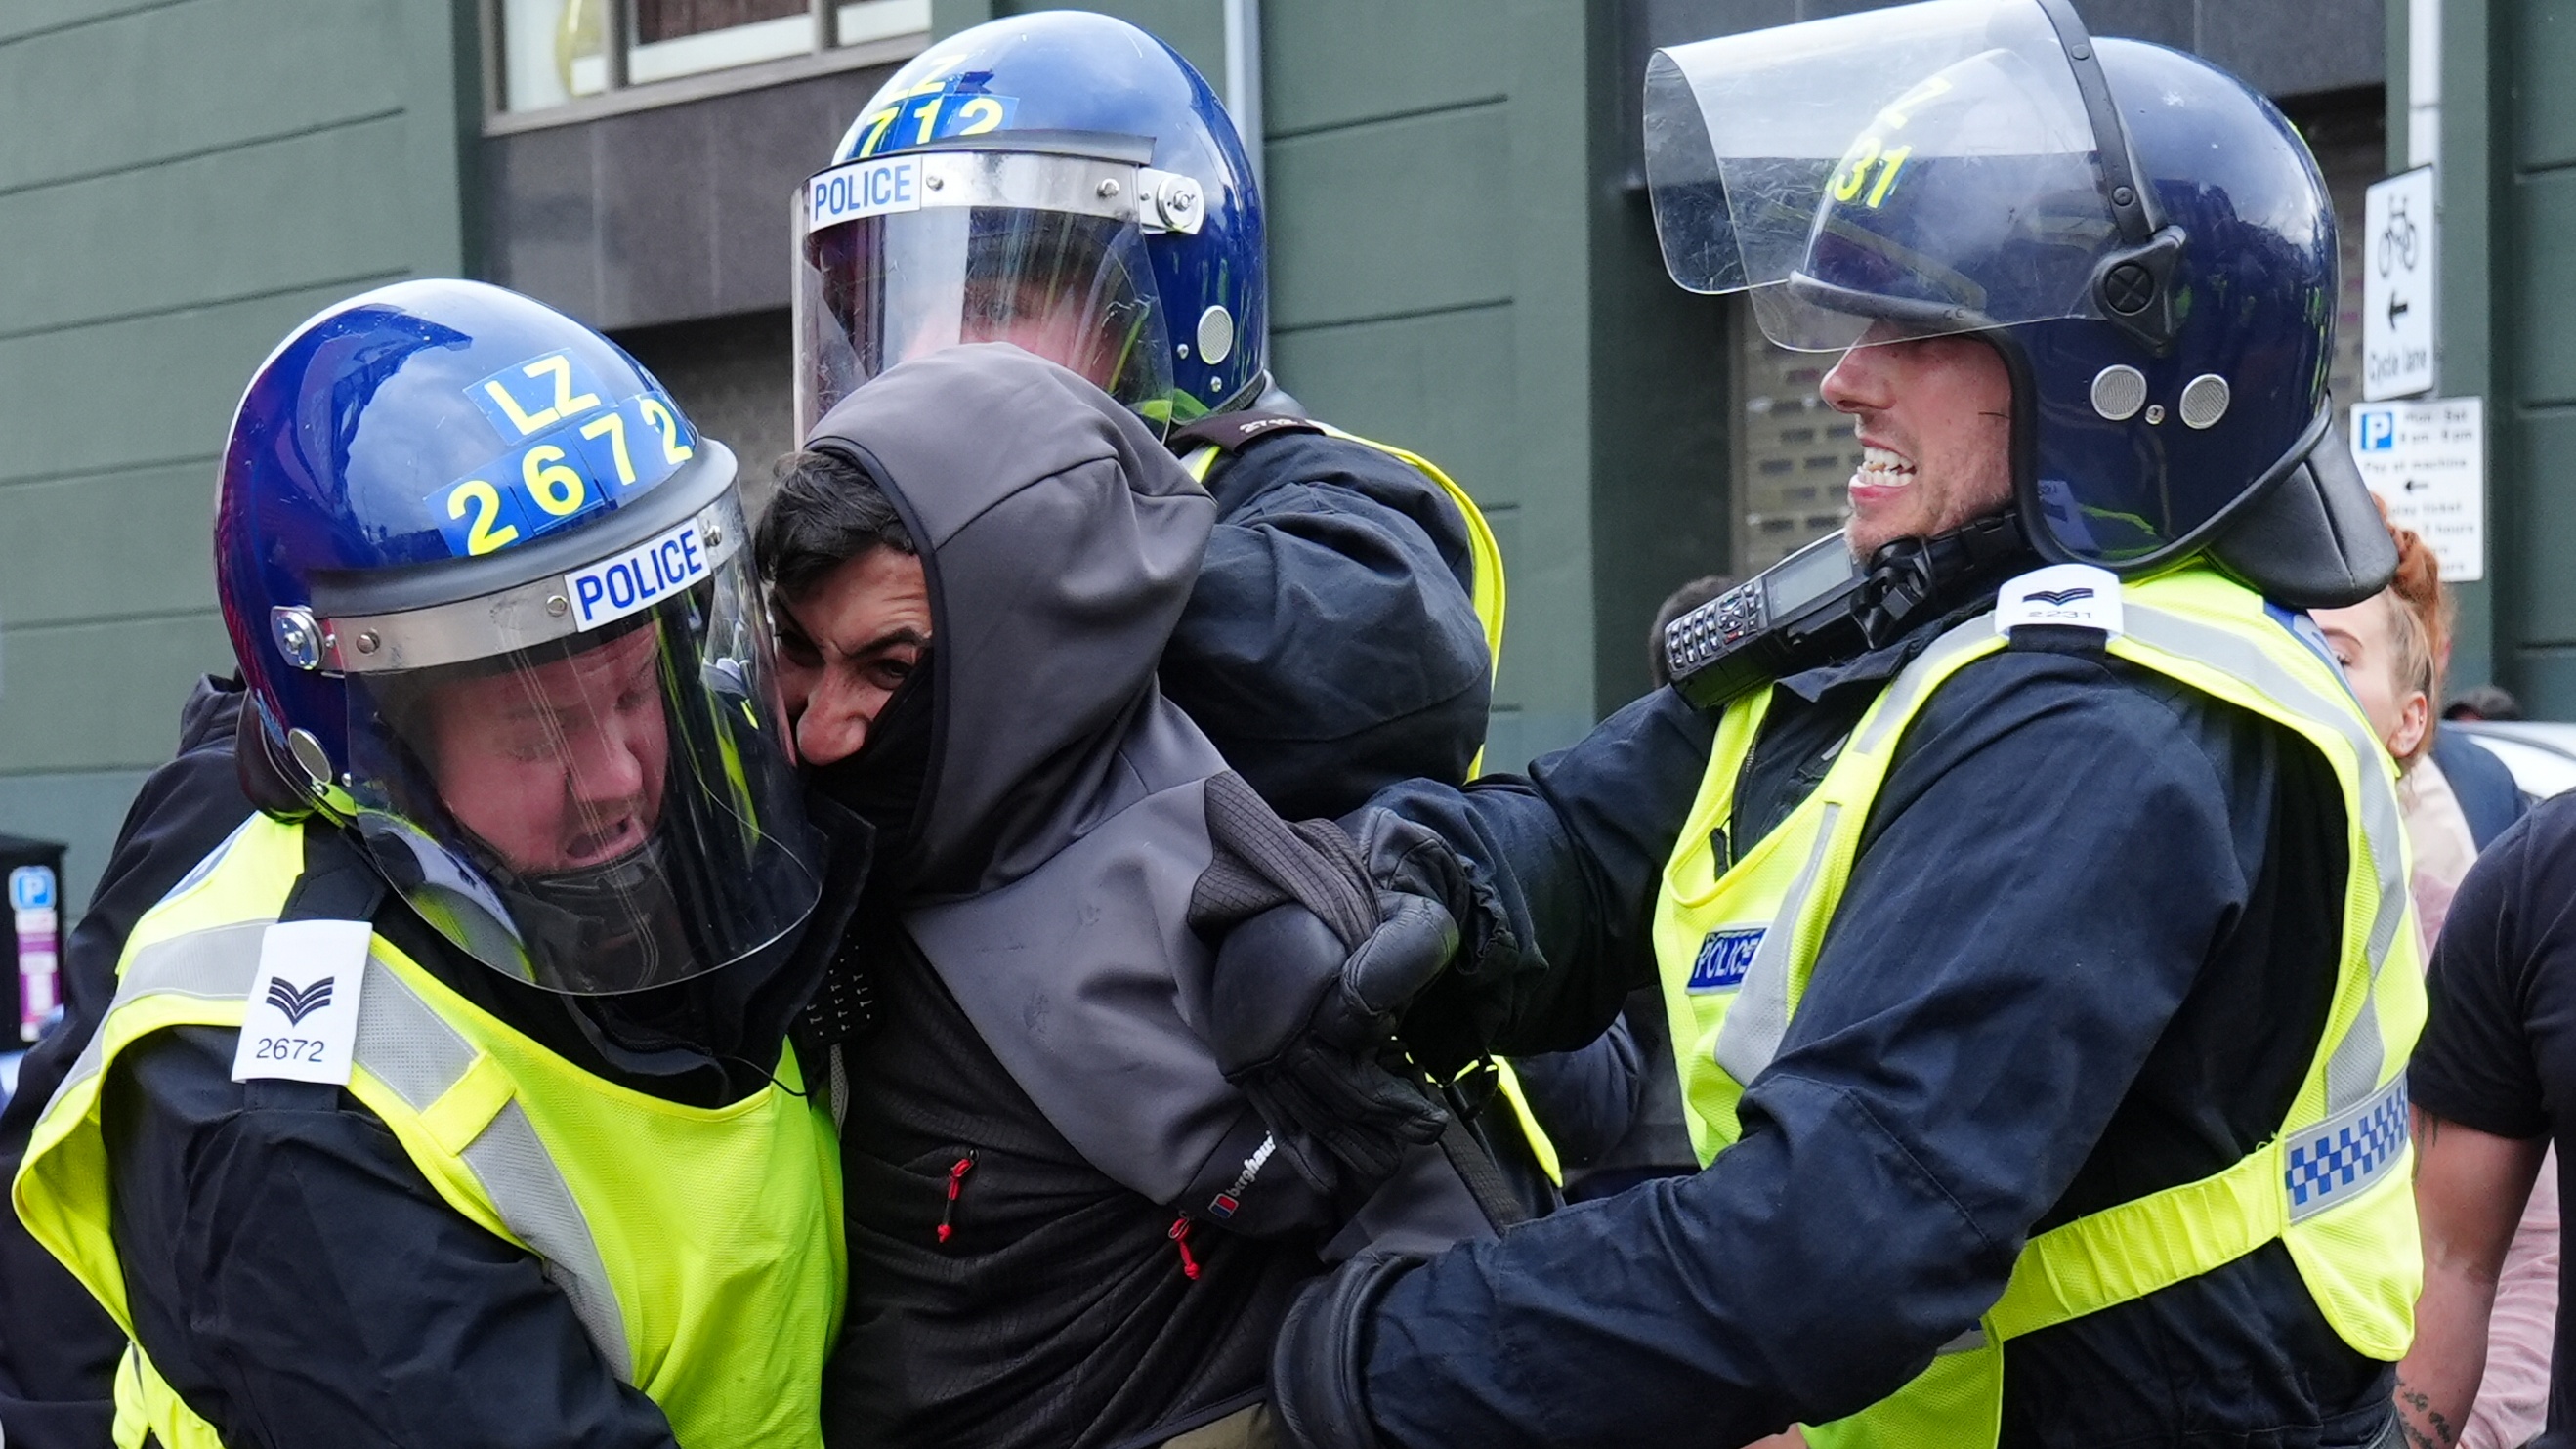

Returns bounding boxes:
[1646,0,2395,603]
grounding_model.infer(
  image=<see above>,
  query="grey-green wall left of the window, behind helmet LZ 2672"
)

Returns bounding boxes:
[0,0,474,908]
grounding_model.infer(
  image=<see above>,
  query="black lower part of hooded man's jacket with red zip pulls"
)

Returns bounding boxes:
[824,923,1322,1449]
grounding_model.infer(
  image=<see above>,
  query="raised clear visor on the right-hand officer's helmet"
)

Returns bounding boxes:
[1646,0,2120,351]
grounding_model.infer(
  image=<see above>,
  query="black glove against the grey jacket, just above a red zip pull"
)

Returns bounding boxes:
[1208,895,1458,1194]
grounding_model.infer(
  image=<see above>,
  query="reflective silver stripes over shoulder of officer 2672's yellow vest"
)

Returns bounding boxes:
[54,920,634,1382]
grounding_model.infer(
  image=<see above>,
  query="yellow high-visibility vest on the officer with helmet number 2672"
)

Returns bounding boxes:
[13,815,848,1449]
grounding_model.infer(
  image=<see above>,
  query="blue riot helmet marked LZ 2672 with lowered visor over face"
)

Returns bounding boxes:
[214,281,820,996]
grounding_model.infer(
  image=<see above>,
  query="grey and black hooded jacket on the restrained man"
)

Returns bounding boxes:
[809,346,1483,1446]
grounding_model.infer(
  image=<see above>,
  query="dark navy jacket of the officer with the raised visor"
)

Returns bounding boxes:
[1363,600,2390,1449]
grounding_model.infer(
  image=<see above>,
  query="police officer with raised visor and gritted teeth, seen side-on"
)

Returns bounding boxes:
[1195,0,2424,1449]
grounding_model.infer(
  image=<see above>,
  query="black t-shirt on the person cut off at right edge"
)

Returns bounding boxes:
[2406,794,2576,1444]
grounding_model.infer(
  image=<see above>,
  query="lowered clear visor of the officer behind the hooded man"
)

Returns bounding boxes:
[796,152,1172,436]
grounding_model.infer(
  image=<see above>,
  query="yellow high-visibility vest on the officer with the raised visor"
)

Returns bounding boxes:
[1654,568,2424,1449]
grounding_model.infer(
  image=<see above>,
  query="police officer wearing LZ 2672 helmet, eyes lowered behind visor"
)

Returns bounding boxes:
[16,281,850,1449]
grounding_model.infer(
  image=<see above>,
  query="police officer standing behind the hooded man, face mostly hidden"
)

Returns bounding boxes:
[796,11,1501,817]
